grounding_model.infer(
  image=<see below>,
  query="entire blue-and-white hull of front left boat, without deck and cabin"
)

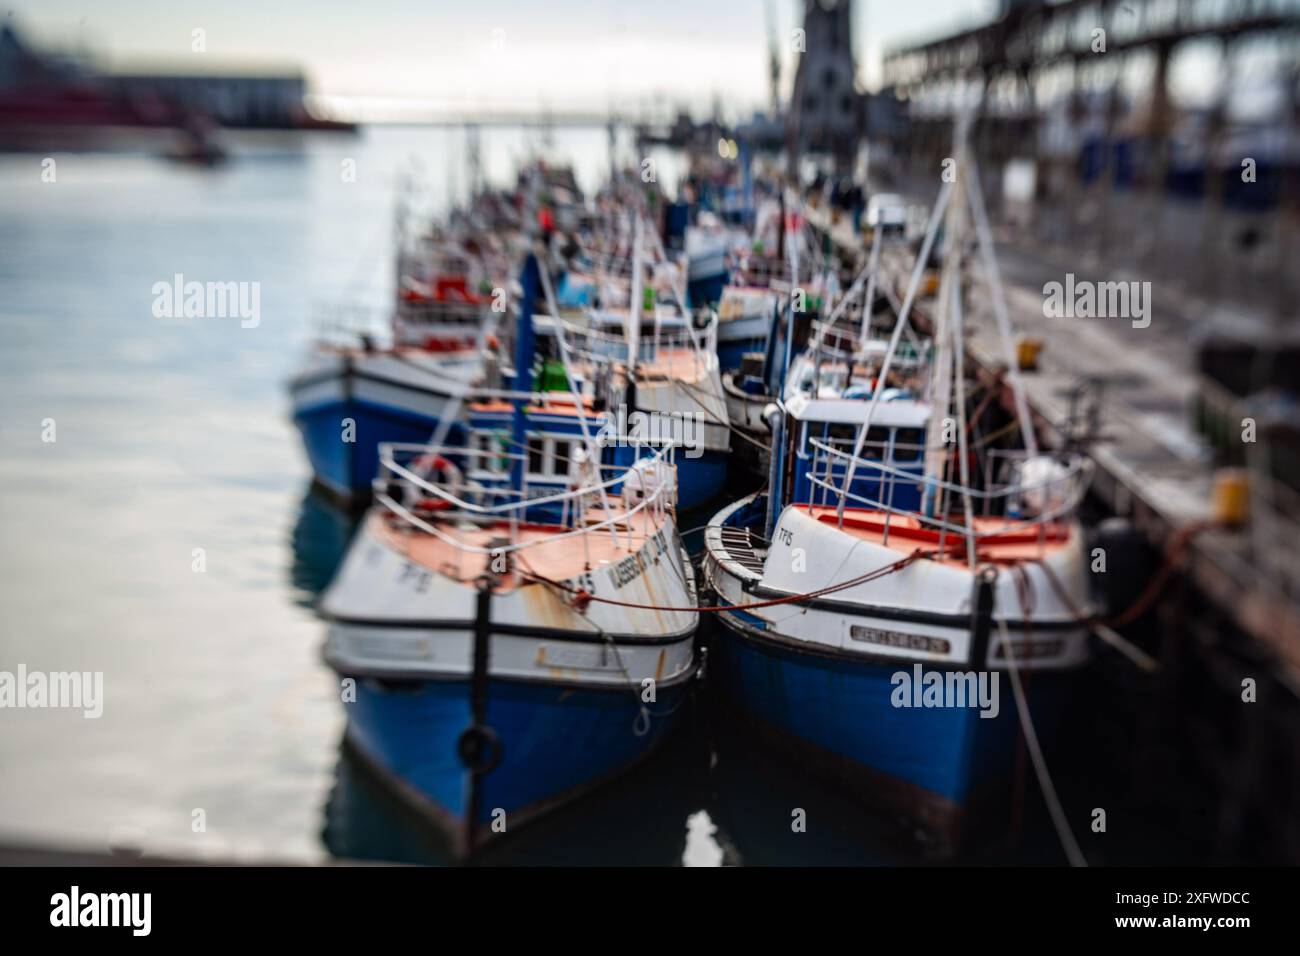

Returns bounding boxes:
[321,516,698,856]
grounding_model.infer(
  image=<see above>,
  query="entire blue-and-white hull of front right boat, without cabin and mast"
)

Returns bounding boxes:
[705,496,1087,849]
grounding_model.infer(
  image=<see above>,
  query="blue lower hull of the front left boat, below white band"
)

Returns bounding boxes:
[347,679,688,851]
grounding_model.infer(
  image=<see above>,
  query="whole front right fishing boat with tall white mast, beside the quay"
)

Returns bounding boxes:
[705,164,1092,849]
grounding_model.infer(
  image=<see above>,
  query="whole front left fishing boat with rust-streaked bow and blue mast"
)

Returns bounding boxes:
[321,256,697,857]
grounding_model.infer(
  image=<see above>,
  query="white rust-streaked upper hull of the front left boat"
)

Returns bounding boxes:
[321,515,698,687]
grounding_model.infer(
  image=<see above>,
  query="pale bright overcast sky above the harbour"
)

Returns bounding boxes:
[0,0,996,114]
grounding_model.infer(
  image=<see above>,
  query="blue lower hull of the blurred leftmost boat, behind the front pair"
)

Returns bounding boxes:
[294,398,460,501]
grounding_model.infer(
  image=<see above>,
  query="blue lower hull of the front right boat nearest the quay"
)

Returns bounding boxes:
[711,621,1063,840]
